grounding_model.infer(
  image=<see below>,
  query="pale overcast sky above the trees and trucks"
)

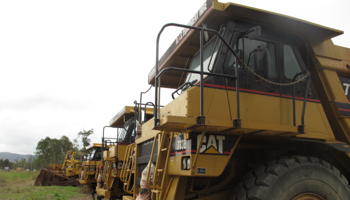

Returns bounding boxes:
[0,0,350,154]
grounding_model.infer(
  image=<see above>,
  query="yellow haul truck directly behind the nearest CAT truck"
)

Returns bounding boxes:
[96,103,153,199]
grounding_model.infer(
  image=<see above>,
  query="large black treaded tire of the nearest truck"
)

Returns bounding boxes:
[231,156,350,200]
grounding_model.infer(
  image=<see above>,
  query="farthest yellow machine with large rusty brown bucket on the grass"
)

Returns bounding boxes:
[34,151,81,186]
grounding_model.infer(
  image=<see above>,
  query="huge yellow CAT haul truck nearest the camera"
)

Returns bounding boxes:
[119,0,350,200]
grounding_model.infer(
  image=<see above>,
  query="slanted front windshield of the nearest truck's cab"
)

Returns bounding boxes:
[185,36,219,84]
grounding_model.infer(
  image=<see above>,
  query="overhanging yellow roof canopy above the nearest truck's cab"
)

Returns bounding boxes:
[148,0,343,88]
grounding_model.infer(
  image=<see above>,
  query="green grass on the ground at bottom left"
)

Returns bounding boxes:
[0,171,82,200]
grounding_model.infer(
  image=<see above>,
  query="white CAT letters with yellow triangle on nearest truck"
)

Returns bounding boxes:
[197,134,225,154]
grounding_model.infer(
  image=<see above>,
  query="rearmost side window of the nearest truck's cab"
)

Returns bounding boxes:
[283,45,301,80]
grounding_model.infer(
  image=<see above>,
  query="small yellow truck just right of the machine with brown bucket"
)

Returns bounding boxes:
[79,143,102,191]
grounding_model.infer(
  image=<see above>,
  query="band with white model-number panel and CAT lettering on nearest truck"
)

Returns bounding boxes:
[170,133,238,156]
